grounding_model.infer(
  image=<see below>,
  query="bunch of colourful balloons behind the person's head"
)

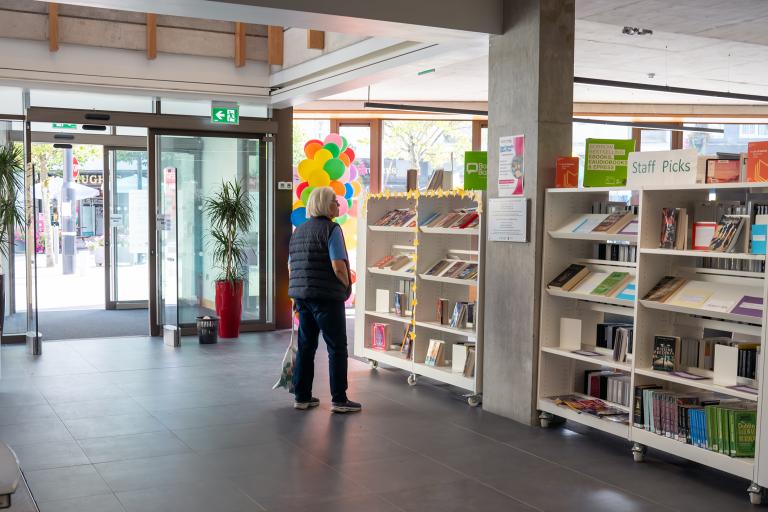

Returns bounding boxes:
[291,133,363,227]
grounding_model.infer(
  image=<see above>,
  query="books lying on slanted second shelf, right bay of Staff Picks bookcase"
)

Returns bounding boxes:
[643,276,763,318]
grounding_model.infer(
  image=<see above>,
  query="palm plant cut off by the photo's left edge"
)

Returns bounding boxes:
[0,143,24,335]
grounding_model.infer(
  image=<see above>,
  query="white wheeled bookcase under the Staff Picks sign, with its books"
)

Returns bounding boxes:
[537,183,768,503]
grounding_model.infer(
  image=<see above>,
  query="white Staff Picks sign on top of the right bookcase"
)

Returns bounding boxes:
[627,149,699,189]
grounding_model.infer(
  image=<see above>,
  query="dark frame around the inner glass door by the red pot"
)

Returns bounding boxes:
[147,128,275,336]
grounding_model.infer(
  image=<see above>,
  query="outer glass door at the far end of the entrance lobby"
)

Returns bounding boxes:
[104,148,149,309]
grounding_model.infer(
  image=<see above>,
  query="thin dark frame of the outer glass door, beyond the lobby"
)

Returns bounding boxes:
[102,146,152,309]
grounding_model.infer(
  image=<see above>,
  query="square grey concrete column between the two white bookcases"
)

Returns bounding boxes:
[483,0,575,423]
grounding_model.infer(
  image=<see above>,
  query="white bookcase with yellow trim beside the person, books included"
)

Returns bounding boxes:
[354,190,483,407]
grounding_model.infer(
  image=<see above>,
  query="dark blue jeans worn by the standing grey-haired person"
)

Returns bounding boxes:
[293,299,347,403]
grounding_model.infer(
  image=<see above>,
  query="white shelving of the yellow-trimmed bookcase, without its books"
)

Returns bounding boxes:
[354,191,483,406]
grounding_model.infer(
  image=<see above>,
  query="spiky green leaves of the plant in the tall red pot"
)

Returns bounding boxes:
[203,181,253,282]
